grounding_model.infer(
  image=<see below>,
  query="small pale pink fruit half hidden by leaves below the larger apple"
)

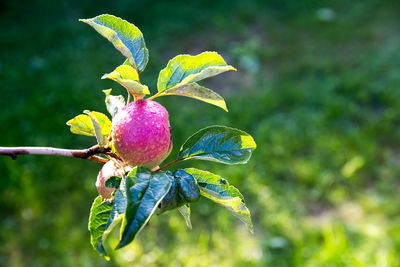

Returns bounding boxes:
[96,160,124,198]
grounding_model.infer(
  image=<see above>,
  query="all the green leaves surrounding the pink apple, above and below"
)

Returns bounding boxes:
[67,14,256,258]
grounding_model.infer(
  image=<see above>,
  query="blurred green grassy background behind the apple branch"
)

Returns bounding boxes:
[0,0,400,266]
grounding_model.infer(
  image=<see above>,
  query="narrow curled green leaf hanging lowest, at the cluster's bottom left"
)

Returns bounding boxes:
[89,196,112,260]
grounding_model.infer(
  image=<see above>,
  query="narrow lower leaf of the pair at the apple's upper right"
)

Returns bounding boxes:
[161,83,228,111]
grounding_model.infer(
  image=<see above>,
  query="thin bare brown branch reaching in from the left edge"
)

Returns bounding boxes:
[0,145,121,164]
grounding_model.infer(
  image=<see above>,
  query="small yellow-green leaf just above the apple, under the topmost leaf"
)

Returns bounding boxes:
[101,65,150,97]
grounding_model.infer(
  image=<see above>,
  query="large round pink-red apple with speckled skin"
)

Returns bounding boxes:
[111,99,172,169]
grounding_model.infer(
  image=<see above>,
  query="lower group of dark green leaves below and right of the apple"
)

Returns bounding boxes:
[89,126,256,257]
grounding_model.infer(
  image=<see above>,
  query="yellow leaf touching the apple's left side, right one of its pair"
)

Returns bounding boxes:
[83,110,112,146]
